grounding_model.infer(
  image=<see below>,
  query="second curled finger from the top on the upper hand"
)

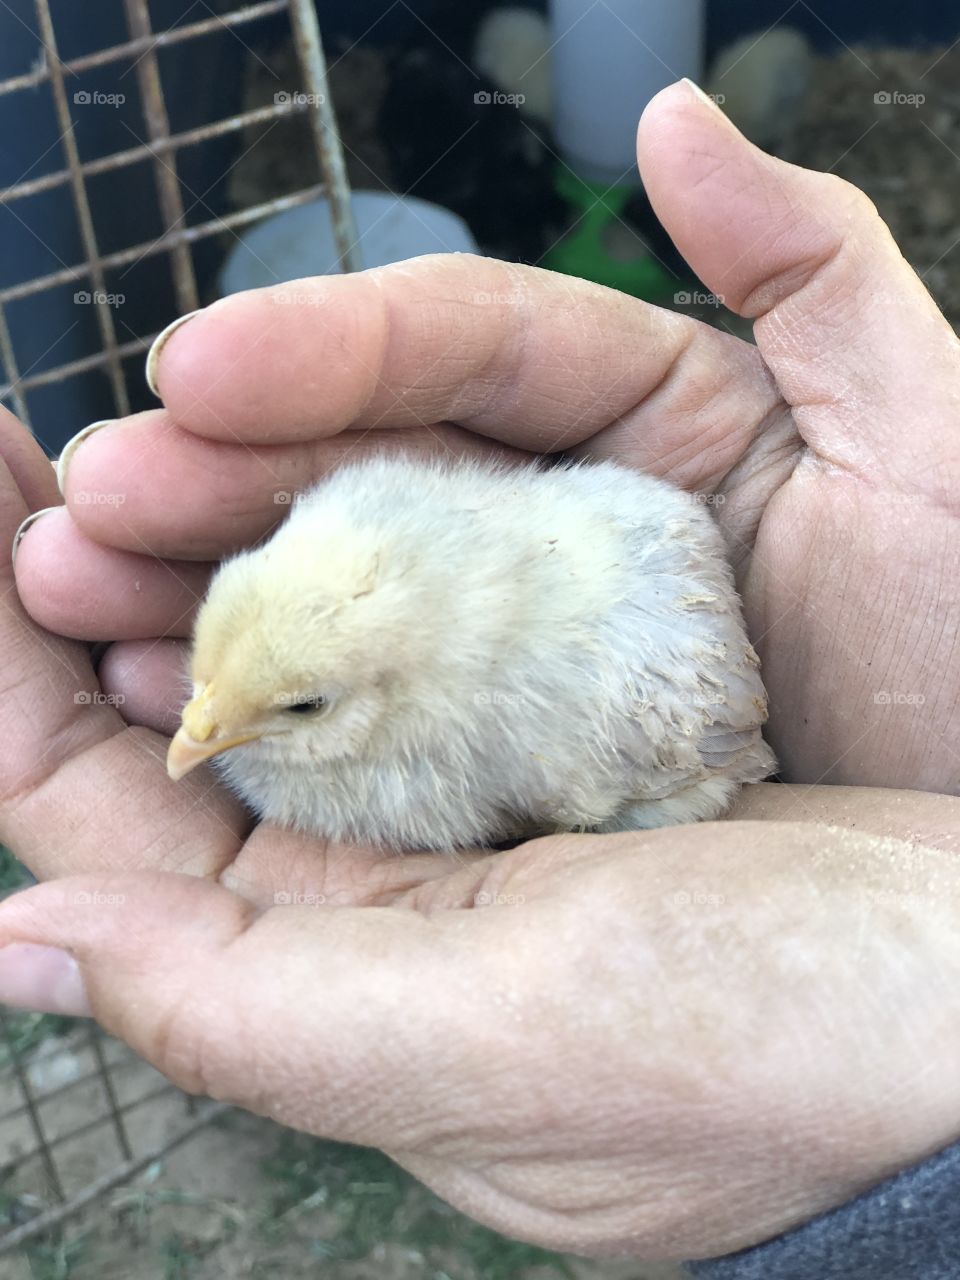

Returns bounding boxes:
[64,410,521,561]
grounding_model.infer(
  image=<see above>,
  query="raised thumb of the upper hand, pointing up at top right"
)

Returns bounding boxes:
[639,83,960,488]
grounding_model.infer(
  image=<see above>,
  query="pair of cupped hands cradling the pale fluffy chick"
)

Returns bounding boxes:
[0,87,960,1256]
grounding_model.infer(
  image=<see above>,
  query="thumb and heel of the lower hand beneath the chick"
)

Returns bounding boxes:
[0,808,960,1258]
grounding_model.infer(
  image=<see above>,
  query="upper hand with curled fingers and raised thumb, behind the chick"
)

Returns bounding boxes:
[18,86,960,791]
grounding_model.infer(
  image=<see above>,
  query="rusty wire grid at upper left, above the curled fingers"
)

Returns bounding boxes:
[0,0,360,425]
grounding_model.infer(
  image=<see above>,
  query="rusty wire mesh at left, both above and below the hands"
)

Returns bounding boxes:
[0,0,360,1253]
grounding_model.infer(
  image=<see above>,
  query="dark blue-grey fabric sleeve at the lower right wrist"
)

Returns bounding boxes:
[689,1144,960,1280]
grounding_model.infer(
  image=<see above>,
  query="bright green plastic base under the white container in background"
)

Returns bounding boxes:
[543,165,677,302]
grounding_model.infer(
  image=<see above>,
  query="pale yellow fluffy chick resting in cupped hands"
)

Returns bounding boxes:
[168,456,774,849]
